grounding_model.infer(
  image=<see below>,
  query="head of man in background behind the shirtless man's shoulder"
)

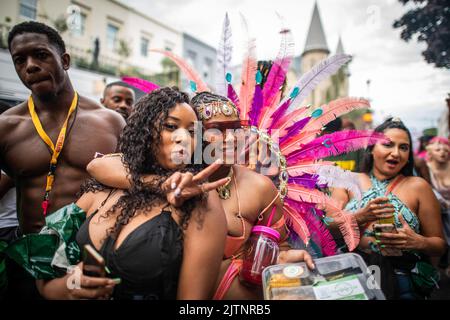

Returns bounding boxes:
[100,81,135,120]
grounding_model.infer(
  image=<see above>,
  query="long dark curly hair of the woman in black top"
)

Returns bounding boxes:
[83,87,202,237]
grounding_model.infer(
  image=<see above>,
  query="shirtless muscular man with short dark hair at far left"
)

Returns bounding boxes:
[0,22,125,298]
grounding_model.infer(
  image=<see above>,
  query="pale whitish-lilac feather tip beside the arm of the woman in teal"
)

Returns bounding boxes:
[316,166,362,200]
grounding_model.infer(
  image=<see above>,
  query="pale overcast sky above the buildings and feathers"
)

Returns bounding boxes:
[123,0,450,138]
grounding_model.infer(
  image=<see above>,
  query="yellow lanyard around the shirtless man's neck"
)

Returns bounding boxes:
[28,92,78,216]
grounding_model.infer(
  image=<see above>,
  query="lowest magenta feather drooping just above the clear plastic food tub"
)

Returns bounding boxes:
[286,199,336,256]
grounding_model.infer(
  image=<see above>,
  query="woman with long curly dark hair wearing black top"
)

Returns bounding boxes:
[34,88,226,299]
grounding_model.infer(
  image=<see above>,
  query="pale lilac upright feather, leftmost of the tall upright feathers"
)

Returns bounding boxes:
[216,13,233,96]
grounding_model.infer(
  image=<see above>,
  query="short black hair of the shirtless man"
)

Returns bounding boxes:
[8,21,66,53]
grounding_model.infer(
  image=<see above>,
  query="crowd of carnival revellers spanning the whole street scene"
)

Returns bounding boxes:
[0,22,450,300]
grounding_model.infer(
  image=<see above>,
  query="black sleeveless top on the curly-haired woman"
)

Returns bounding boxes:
[76,210,183,300]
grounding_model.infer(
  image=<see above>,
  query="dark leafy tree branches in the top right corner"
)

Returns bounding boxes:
[393,0,450,69]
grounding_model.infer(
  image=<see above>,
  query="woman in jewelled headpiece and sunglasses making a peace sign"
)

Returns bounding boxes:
[88,92,314,300]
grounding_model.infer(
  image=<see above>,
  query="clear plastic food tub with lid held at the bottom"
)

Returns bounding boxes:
[262,253,385,300]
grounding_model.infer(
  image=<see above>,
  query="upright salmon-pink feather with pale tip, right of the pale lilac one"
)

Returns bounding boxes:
[239,15,258,120]
